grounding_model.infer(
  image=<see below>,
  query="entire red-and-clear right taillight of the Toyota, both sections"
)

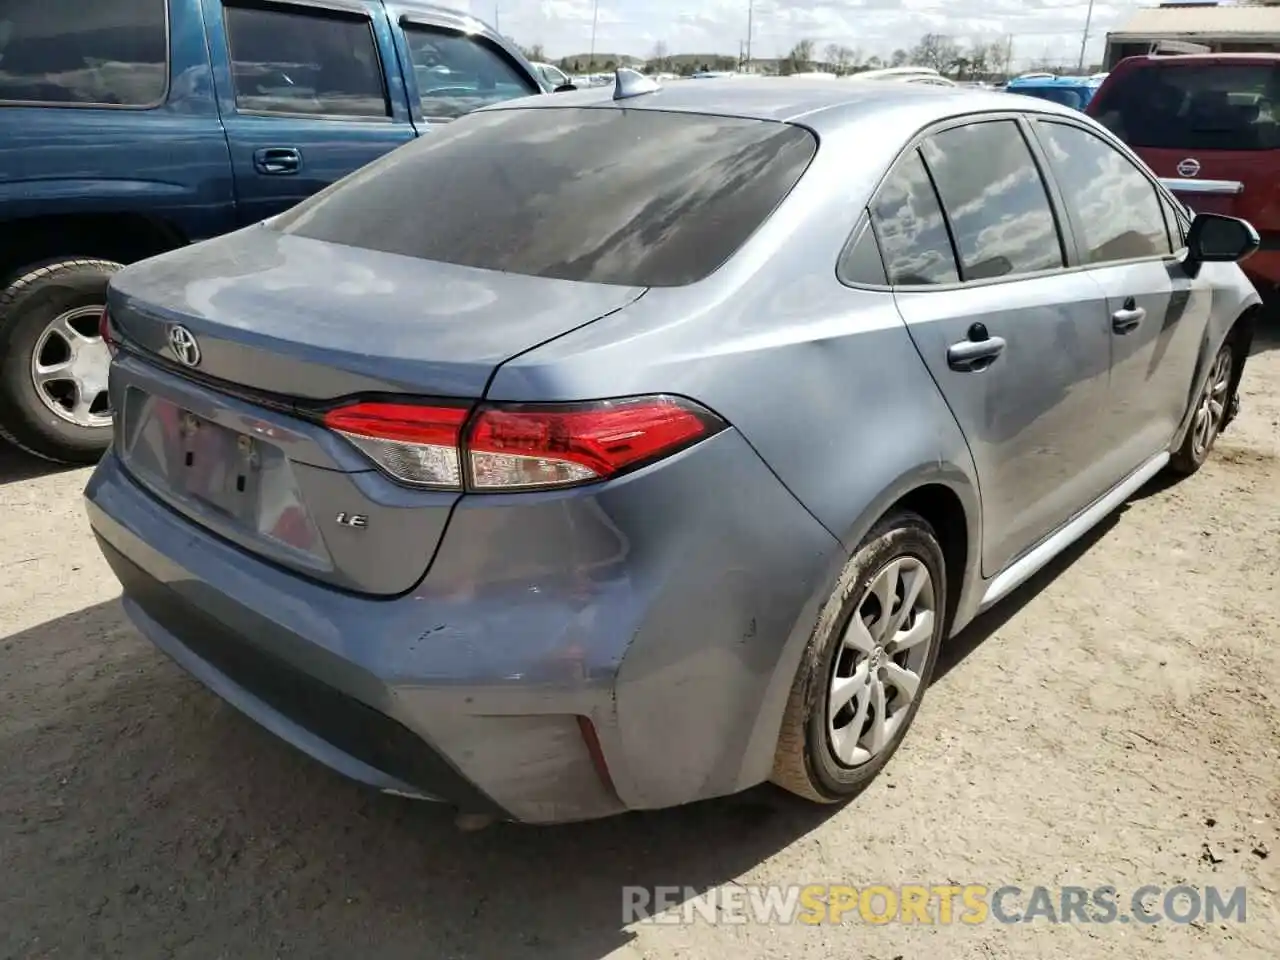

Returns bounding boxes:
[324,396,726,492]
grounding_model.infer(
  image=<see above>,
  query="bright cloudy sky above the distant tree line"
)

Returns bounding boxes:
[460,0,1153,65]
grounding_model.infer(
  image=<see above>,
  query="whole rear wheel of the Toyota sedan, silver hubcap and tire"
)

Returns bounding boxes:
[772,511,946,803]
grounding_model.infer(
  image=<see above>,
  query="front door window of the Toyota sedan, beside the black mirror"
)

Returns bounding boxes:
[1038,122,1171,264]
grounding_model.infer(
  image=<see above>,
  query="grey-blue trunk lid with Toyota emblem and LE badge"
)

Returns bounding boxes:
[109,227,644,595]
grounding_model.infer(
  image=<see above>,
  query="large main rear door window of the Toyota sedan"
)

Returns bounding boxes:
[922,120,1064,280]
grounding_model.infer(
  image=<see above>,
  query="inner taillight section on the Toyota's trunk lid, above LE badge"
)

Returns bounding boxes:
[324,403,468,490]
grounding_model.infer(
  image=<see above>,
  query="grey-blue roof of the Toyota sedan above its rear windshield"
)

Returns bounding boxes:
[484,77,1076,128]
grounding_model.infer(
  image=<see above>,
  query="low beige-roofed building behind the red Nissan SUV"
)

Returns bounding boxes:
[1105,0,1280,69]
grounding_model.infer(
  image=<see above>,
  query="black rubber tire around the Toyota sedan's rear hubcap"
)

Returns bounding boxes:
[771,511,947,804]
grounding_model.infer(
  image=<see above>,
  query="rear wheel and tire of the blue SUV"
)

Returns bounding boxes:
[0,260,120,463]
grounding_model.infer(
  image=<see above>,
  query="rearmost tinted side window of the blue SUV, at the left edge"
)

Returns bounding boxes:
[0,0,169,106]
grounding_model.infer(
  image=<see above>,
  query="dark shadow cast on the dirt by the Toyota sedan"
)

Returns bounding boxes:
[0,520,1115,960]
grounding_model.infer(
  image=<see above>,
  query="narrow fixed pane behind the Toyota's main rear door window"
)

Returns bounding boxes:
[872,150,960,287]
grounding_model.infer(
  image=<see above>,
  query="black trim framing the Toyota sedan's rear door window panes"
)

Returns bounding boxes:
[837,110,1080,293]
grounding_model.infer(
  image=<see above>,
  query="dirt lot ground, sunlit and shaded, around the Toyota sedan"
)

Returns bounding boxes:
[0,325,1280,960]
